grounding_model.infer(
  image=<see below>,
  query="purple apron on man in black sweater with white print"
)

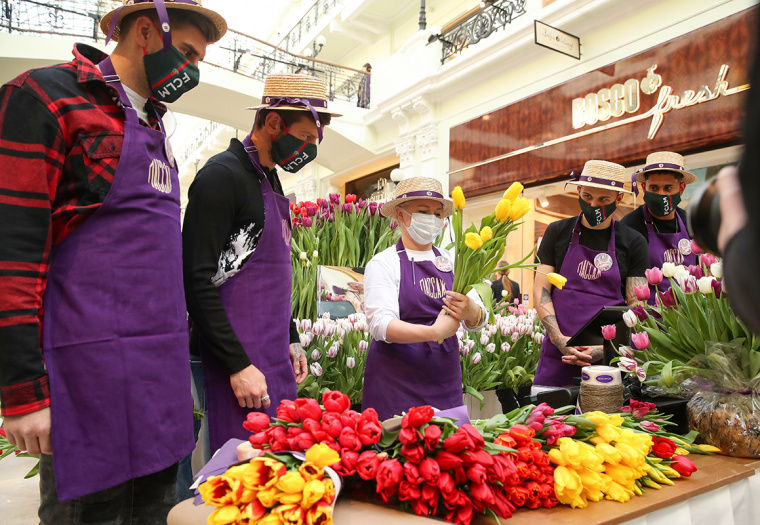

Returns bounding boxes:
[201,137,296,451]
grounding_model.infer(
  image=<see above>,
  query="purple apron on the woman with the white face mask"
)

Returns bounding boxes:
[362,241,462,420]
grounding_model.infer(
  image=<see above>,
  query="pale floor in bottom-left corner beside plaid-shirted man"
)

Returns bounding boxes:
[0,450,40,525]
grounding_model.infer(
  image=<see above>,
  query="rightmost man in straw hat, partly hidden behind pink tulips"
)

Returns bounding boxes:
[620,151,697,305]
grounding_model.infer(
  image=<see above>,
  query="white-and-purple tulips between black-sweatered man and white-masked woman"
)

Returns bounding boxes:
[296,314,370,405]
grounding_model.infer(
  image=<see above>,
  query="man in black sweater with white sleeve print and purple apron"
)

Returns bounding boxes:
[183,75,339,451]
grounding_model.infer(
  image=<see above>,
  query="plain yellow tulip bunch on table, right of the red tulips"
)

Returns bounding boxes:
[549,412,652,508]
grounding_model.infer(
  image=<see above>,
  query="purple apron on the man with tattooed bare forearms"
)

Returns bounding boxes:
[533,215,625,387]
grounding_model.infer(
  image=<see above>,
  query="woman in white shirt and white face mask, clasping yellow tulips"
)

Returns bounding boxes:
[362,177,487,420]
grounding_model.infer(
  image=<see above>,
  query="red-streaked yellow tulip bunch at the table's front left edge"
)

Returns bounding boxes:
[198,445,340,525]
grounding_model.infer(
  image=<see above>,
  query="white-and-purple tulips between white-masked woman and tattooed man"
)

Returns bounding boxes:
[457,305,545,398]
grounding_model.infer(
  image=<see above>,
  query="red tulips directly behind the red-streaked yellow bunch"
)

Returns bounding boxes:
[243,390,383,476]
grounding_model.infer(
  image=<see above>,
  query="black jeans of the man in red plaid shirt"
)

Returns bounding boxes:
[39,454,177,525]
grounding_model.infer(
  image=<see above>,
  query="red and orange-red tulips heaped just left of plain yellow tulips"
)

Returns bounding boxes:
[358,406,558,524]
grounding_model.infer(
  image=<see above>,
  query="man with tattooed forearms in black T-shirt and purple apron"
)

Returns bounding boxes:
[533,160,649,386]
